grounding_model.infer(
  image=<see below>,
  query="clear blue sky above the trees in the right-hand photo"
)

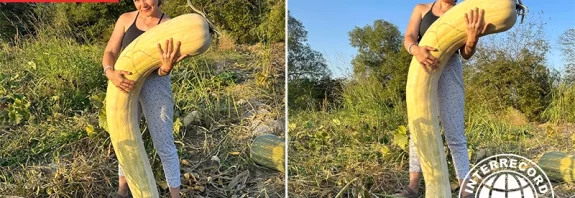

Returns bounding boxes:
[288,0,575,77]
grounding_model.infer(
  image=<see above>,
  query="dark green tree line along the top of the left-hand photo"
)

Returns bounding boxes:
[0,0,285,44]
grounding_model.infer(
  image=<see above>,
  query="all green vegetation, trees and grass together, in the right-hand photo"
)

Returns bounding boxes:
[288,12,575,197]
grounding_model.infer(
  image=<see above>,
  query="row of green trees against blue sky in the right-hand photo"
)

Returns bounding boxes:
[288,10,575,121]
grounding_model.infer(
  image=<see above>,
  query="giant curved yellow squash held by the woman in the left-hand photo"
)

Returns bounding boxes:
[106,14,212,198]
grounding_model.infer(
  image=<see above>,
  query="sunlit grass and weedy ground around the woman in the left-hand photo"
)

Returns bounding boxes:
[0,27,285,197]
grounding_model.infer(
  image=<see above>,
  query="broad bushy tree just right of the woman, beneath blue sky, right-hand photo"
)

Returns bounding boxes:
[464,17,558,121]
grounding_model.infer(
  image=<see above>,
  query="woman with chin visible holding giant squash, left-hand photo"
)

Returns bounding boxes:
[102,0,186,197]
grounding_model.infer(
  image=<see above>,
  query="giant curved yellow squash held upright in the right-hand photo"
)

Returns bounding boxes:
[406,0,517,198]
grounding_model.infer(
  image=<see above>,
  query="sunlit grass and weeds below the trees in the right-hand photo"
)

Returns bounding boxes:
[288,79,575,197]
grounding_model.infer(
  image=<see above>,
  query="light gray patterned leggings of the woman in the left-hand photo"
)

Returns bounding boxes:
[118,72,181,188]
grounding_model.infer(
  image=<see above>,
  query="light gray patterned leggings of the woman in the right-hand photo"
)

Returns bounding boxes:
[409,54,469,179]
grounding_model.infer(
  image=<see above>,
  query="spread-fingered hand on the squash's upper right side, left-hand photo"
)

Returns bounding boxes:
[158,38,188,76]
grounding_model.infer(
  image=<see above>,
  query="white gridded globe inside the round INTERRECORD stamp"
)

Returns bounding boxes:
[475,171,538,198]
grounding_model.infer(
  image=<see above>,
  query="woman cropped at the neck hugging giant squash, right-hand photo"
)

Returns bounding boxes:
[396,0,487,197]
